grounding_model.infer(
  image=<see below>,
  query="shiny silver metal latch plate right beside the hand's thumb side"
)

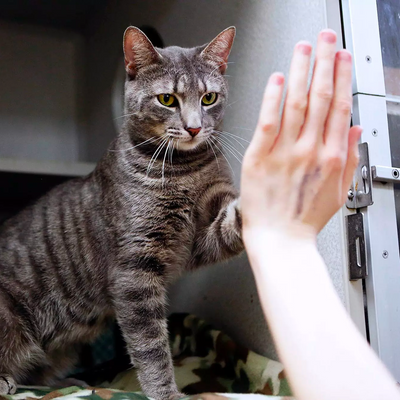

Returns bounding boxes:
[346,143,374,208]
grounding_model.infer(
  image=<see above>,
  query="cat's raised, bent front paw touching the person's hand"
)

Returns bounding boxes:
[192,191,244,266]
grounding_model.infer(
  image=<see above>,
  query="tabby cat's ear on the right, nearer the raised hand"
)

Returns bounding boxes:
[200,26,236,74]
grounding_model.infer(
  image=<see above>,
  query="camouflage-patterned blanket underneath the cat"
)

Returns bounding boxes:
[0,314,291,400]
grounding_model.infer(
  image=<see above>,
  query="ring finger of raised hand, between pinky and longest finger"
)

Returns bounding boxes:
[279,42,312,143]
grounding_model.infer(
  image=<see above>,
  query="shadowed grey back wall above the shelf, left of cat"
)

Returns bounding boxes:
[0,21,85,161]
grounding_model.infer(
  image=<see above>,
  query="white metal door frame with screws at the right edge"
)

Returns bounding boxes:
[341,0,400,381]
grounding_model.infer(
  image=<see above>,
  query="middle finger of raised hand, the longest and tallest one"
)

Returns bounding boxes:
[301,29,336,143]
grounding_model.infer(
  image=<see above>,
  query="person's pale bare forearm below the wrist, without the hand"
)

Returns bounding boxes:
[245,230,400,400]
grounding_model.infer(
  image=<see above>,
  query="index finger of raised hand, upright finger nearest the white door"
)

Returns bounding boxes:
[325,50,353,150]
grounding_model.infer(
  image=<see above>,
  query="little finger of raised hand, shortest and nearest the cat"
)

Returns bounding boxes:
[250,73,285,154]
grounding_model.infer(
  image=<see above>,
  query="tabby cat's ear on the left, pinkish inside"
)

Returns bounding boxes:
[123,26,162,78]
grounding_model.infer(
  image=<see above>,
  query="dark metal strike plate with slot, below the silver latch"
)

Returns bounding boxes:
[346,213,368,281]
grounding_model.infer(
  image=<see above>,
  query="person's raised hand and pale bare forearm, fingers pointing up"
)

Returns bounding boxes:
[241,30,400,400]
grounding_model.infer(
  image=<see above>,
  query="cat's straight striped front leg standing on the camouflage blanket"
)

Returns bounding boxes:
[113,268,184,400]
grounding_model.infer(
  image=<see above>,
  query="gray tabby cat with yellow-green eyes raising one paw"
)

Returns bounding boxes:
[0,27,243,399]
